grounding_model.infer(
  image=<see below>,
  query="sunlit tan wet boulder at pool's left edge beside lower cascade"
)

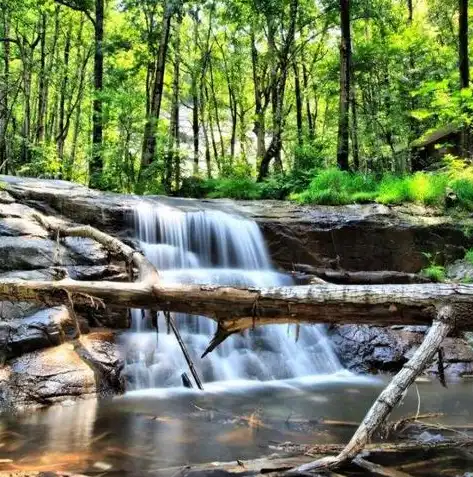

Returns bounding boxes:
[0,332,122,409]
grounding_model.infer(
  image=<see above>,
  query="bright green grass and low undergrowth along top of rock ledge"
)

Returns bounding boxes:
[179,157,473,211]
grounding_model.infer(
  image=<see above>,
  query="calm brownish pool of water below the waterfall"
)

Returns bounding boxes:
[0,372,473,476]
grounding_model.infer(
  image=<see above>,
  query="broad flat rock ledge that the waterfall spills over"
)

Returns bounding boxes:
[0,176,473,272]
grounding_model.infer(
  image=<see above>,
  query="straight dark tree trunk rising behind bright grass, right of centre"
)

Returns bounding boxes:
[337,0,351,171]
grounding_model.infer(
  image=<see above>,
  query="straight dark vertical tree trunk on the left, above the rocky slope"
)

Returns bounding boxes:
[89,0,104,189]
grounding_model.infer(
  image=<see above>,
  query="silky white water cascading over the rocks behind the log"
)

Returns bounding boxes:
[124,203,343,390]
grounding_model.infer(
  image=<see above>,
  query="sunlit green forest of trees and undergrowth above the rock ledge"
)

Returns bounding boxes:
[0,0,473,205]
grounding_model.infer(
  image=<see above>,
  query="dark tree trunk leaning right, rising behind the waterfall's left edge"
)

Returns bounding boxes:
[141,0,174,170]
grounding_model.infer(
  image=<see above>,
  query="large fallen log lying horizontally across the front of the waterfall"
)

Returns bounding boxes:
[4,279,473,333]
